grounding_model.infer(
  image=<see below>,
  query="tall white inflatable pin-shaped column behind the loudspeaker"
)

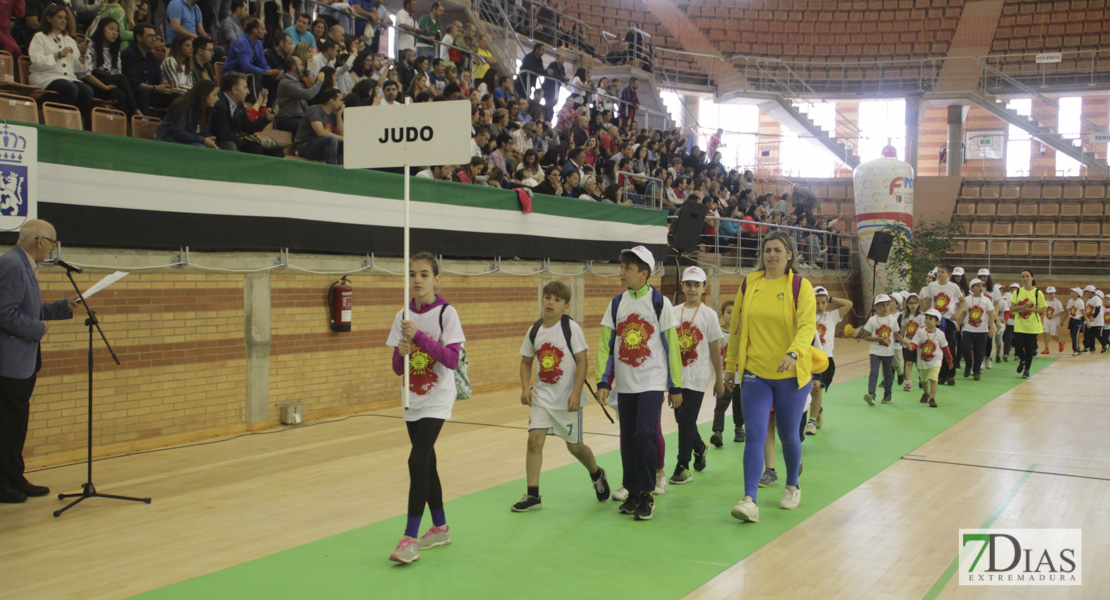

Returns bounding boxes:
[852,145,914,297]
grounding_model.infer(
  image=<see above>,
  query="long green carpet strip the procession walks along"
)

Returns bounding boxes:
[137,358,1052,600]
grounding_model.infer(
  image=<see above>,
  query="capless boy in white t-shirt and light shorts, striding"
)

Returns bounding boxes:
[513,282,609,512]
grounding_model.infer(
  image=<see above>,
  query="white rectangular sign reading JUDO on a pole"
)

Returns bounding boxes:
[343,100,471,169]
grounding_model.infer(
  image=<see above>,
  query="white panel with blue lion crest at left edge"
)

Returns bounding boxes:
[0,122,39,232]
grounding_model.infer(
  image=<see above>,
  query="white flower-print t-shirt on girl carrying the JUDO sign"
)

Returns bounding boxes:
[385,304,466,420]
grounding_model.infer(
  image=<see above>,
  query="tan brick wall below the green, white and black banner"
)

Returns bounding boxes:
[24,256,850,468]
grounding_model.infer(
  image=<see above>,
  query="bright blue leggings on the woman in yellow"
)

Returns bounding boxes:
[740,370,814,500]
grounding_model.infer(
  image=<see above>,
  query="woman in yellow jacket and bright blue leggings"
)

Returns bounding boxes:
[725,232,817,522]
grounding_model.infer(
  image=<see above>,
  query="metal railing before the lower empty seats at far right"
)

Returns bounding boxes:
[950,236,1110,276]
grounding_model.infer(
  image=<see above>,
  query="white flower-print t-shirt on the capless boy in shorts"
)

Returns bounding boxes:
[521,321,589,410]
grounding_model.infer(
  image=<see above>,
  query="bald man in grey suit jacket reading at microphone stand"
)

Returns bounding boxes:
[0,220,78,504]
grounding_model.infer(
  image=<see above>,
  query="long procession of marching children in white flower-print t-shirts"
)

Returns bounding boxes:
[386,246,1110,563]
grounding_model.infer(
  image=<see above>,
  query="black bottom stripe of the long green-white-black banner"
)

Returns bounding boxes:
[0,202,666,261]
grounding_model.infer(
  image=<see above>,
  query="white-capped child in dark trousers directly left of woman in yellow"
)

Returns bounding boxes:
[670,266,725,485]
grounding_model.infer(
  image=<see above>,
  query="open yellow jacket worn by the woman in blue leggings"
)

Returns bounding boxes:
[725,271,817,389]
